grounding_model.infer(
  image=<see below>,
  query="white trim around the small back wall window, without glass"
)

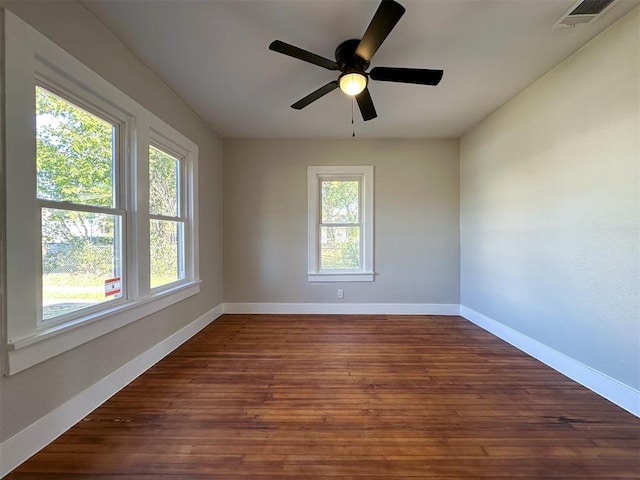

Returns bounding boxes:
[307,165,375,282]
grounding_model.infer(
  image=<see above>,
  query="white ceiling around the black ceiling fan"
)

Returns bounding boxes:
[83,0,640,138]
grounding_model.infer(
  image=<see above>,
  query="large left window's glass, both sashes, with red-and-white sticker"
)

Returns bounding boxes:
[35,85,124,322]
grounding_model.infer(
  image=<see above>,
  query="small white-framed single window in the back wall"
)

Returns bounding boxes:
[307,166,374,282]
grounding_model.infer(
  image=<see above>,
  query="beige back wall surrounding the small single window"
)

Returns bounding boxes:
[224,139,459,304]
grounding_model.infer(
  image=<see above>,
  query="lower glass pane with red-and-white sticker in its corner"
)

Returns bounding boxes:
[42,208,122,320]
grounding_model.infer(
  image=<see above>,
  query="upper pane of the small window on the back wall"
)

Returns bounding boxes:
[320,180,360,223]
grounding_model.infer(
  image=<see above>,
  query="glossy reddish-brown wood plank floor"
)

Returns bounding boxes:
[8,315,640,480]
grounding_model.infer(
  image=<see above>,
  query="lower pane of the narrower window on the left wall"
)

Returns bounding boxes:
[149,220,184,288]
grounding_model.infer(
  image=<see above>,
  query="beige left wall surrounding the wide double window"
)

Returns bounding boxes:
[0,2,222,443]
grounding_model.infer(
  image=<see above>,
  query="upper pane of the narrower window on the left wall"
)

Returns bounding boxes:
[149,147,180,217]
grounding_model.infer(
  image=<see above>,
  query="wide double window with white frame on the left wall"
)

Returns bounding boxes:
[2,11,199,375]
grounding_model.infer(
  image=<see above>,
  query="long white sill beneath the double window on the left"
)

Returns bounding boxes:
[5,280,201,375]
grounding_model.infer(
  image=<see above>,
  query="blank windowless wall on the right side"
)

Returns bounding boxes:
[460,8,640,390]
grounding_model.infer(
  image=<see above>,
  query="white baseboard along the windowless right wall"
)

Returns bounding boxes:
[460,305,640,417]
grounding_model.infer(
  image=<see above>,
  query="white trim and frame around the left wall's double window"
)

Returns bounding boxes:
[2,10,200,375]
